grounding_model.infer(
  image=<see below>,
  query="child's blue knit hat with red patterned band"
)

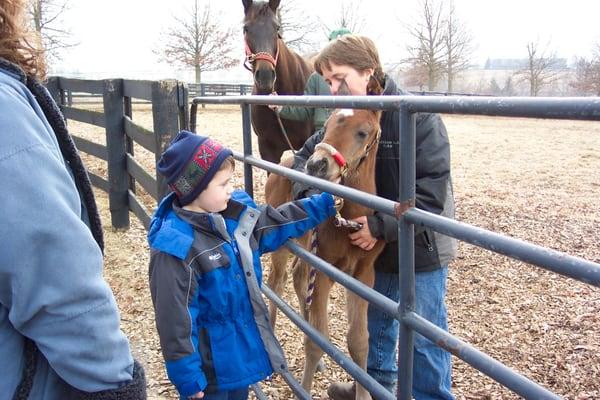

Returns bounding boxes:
[156,131,233,206]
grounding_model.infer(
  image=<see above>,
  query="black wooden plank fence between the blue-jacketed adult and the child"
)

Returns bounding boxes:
[47,77,189,228]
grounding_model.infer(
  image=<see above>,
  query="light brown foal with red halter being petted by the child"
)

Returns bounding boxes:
[265,104,383,400]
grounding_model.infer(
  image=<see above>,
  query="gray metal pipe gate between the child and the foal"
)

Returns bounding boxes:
[190,96,600,400]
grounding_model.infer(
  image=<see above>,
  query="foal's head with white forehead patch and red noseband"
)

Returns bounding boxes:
[306,109,381,182]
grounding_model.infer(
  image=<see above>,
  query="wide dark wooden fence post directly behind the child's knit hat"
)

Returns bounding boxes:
[152,80,187,201]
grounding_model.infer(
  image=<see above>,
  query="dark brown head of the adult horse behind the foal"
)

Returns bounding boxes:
[242,0,280,94]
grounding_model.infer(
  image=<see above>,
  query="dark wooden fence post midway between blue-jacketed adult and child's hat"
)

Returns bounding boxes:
[102,79,129,228]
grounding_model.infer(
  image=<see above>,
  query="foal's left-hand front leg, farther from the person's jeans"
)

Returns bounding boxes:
[302,272,333,392]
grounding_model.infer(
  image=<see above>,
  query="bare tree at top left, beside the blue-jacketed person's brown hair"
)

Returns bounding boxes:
[28,0,78,61]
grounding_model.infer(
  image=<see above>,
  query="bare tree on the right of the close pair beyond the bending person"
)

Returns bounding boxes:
[444,0,473,92]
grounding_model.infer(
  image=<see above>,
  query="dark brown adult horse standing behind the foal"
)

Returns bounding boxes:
[242,0,314,163]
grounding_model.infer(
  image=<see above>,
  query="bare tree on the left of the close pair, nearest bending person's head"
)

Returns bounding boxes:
[406,0,446,90]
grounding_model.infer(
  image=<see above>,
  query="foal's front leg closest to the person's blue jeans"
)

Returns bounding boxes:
[346,263,375,400]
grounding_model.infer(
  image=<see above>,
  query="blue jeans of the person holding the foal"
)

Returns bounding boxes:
[367,266,454,400]
